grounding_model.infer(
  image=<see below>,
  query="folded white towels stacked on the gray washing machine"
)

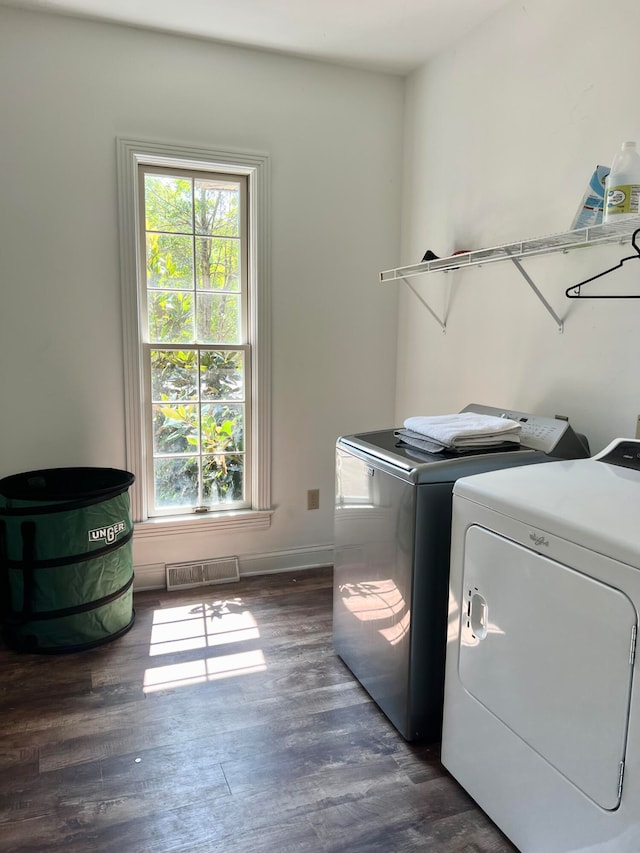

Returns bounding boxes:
[395,412,522,453]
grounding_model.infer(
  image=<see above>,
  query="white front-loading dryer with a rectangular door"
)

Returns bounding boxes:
[442,439,640,853]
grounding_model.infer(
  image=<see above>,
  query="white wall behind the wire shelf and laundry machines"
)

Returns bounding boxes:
[398,0,640,450]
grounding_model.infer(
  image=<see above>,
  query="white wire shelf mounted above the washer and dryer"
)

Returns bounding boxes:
[380,216,640,282]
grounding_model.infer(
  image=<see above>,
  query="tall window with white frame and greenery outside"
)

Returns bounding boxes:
[118,140,269,530]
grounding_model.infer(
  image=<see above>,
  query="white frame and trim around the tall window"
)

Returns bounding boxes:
[117,138,272,537]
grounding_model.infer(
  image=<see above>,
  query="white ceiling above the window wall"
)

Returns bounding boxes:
[0,0,510,74]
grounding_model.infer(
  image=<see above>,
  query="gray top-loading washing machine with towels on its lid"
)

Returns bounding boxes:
[333,403,589,741]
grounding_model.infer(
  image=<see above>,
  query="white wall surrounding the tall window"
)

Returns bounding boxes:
[0,8,403,584]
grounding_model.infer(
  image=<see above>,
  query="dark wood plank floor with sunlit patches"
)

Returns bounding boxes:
[0,569,514,853]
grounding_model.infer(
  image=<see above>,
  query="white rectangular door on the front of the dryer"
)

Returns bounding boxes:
[458,526,636,809]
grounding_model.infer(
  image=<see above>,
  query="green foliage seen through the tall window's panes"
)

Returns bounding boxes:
[145,174,245,507]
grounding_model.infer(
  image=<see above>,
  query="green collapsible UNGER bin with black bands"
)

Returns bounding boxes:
[0,468,135,653]
